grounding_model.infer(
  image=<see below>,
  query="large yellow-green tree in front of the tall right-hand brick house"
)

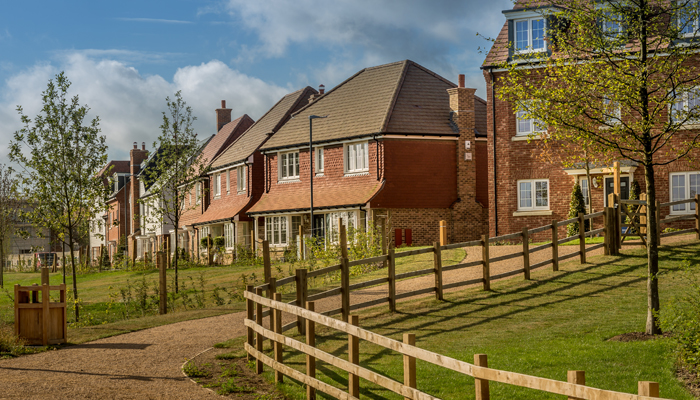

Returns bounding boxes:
[498,0,700,334]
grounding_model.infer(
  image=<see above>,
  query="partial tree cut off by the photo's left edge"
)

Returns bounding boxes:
[0,164,21,288]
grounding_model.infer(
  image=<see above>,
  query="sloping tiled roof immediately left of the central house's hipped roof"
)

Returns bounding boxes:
[211,86,318,169]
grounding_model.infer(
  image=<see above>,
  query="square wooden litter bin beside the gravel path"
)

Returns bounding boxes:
[15,284,68,346]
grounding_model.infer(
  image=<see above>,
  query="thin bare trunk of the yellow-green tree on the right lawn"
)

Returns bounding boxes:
[644,163,661,335]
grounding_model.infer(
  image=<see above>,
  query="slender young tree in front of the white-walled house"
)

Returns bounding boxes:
[142,91,206,293]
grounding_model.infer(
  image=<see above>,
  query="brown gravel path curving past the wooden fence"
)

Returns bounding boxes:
[0,235,691,399]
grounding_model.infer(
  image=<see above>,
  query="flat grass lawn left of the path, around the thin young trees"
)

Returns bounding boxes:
[0,244,465,343]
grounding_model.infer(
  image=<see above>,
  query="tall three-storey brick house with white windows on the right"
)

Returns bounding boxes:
[481,4,700,236]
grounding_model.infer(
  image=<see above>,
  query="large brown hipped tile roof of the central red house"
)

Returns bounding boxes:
[262,60,456,150]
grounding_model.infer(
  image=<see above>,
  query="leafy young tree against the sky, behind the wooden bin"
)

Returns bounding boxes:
[10,72,107,321]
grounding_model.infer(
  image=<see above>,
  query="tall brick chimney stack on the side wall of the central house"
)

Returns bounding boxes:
[447,75,488,242]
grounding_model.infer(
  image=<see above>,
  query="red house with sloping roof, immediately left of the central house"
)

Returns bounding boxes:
[192,86,318,260]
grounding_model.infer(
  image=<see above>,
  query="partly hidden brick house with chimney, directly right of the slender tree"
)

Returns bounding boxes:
[176,100,255,254]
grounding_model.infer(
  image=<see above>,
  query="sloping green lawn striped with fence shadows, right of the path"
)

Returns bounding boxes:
[228,242,700,400]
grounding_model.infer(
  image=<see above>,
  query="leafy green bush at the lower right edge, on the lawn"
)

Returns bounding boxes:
[660,260,700,374]
